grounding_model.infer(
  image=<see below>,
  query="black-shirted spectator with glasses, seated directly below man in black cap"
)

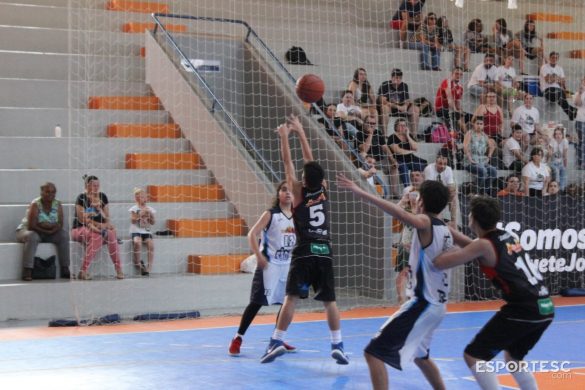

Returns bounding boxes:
[386,118,427,187]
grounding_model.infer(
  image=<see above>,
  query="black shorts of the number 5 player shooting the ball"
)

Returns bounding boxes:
[286,248,335,302]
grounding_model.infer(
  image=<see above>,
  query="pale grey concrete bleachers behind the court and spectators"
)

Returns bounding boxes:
[0,0,585,321]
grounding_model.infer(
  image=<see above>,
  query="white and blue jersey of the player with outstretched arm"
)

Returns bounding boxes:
[406,217,453,305]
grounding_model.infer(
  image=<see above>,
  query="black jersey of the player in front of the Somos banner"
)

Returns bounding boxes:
[480,229,554,319]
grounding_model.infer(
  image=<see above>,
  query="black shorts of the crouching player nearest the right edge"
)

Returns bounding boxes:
[465,310,552,361]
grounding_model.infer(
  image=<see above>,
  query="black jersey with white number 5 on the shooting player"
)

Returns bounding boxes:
[293,186,331,247]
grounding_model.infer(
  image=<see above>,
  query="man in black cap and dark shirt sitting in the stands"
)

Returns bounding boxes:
[377,69,420,138]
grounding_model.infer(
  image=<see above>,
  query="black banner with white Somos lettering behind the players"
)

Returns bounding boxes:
[460,196,585,300]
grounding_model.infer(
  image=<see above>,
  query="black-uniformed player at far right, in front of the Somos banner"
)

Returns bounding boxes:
[435,196,554,389]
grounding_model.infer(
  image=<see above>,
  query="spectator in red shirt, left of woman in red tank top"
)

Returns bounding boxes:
[435,66,471,137]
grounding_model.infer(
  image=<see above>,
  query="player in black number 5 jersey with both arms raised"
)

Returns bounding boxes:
[260,115,349,364]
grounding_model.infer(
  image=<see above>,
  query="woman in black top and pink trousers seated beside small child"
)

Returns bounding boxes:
[71,176,124,280]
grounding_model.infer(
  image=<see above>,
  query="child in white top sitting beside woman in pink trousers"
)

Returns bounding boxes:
[128,188,156,276]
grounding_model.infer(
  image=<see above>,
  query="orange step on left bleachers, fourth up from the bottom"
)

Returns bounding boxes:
[126,153,203,169]
